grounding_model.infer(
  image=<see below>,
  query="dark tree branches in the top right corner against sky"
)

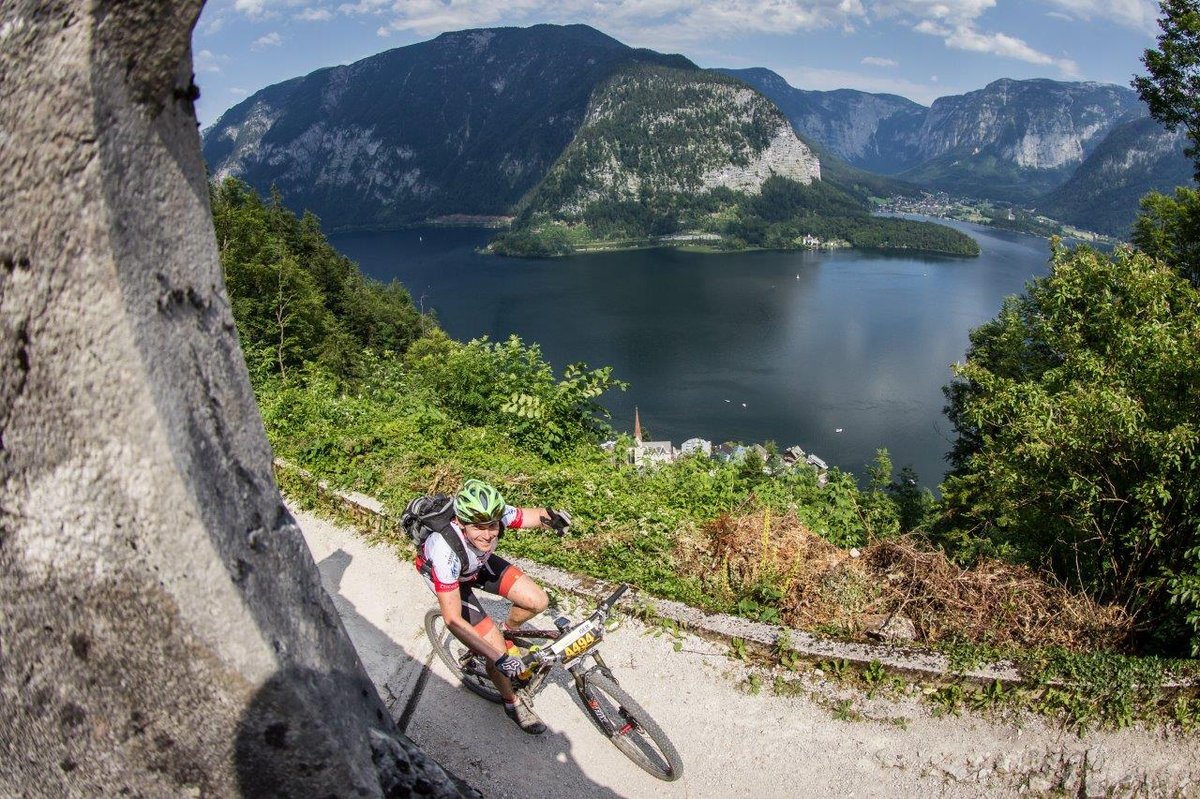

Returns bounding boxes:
[1133,0,1200,180]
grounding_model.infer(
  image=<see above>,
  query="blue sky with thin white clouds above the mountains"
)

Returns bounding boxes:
[192,0,1159,127]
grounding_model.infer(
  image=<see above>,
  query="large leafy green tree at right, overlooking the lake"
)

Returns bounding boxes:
[943,244,1200,650]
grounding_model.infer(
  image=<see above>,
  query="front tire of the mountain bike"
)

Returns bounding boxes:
[583,674,683,782]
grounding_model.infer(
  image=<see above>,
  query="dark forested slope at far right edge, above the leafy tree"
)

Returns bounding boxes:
[1036,116,1194,238]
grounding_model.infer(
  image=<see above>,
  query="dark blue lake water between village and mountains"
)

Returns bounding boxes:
[332,223,1049,486]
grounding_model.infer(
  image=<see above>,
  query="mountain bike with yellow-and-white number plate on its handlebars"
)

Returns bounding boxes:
[425,584,683,782]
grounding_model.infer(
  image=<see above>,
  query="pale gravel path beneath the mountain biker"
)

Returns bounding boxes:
[296,512,1200,799]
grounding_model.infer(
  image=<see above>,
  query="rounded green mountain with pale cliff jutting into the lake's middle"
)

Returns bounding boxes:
[492,66,978,256]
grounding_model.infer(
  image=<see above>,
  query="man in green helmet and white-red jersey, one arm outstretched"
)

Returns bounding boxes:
[416,480,571,735]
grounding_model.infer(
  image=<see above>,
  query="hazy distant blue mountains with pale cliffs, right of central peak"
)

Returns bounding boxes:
[722,68,1146,200]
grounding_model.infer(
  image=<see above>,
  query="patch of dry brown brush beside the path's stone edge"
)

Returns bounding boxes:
[676,512,1132,651]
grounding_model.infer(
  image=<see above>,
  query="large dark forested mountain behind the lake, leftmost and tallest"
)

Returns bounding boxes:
[203,25,695,229]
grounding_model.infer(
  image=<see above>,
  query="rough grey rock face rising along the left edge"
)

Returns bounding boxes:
[0,0,468,795]
